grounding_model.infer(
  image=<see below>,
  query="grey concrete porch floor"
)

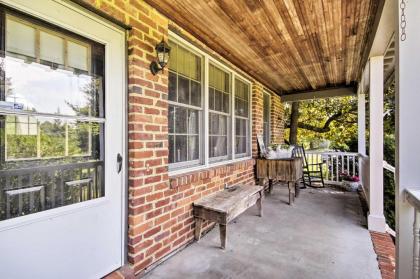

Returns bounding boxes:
[146,185,381,279]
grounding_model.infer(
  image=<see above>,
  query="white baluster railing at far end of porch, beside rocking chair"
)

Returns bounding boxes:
[306,151,360,185]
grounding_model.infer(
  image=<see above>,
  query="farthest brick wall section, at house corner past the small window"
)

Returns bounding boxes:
[270,93,284,143]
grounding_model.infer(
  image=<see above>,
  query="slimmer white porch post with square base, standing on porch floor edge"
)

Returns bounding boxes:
[368,56,385,232]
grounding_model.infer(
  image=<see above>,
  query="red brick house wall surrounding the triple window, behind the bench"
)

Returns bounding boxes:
[80,0,284,276]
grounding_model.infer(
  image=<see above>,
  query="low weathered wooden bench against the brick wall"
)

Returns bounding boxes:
[193,185,264,249]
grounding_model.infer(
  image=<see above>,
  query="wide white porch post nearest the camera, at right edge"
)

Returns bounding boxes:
[394,1,420,279]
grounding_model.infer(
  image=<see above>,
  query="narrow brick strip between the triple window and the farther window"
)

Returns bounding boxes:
[252,82,264,158]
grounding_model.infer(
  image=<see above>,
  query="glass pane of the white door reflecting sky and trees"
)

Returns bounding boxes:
[0,11,105,221]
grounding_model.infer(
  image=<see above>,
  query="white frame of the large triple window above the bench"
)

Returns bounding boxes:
[168,31,252,176]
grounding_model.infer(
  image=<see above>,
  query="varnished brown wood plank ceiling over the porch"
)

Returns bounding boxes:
[146,0,380,94]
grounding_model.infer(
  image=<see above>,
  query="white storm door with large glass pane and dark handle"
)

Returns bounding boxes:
[0,0,126,278]
